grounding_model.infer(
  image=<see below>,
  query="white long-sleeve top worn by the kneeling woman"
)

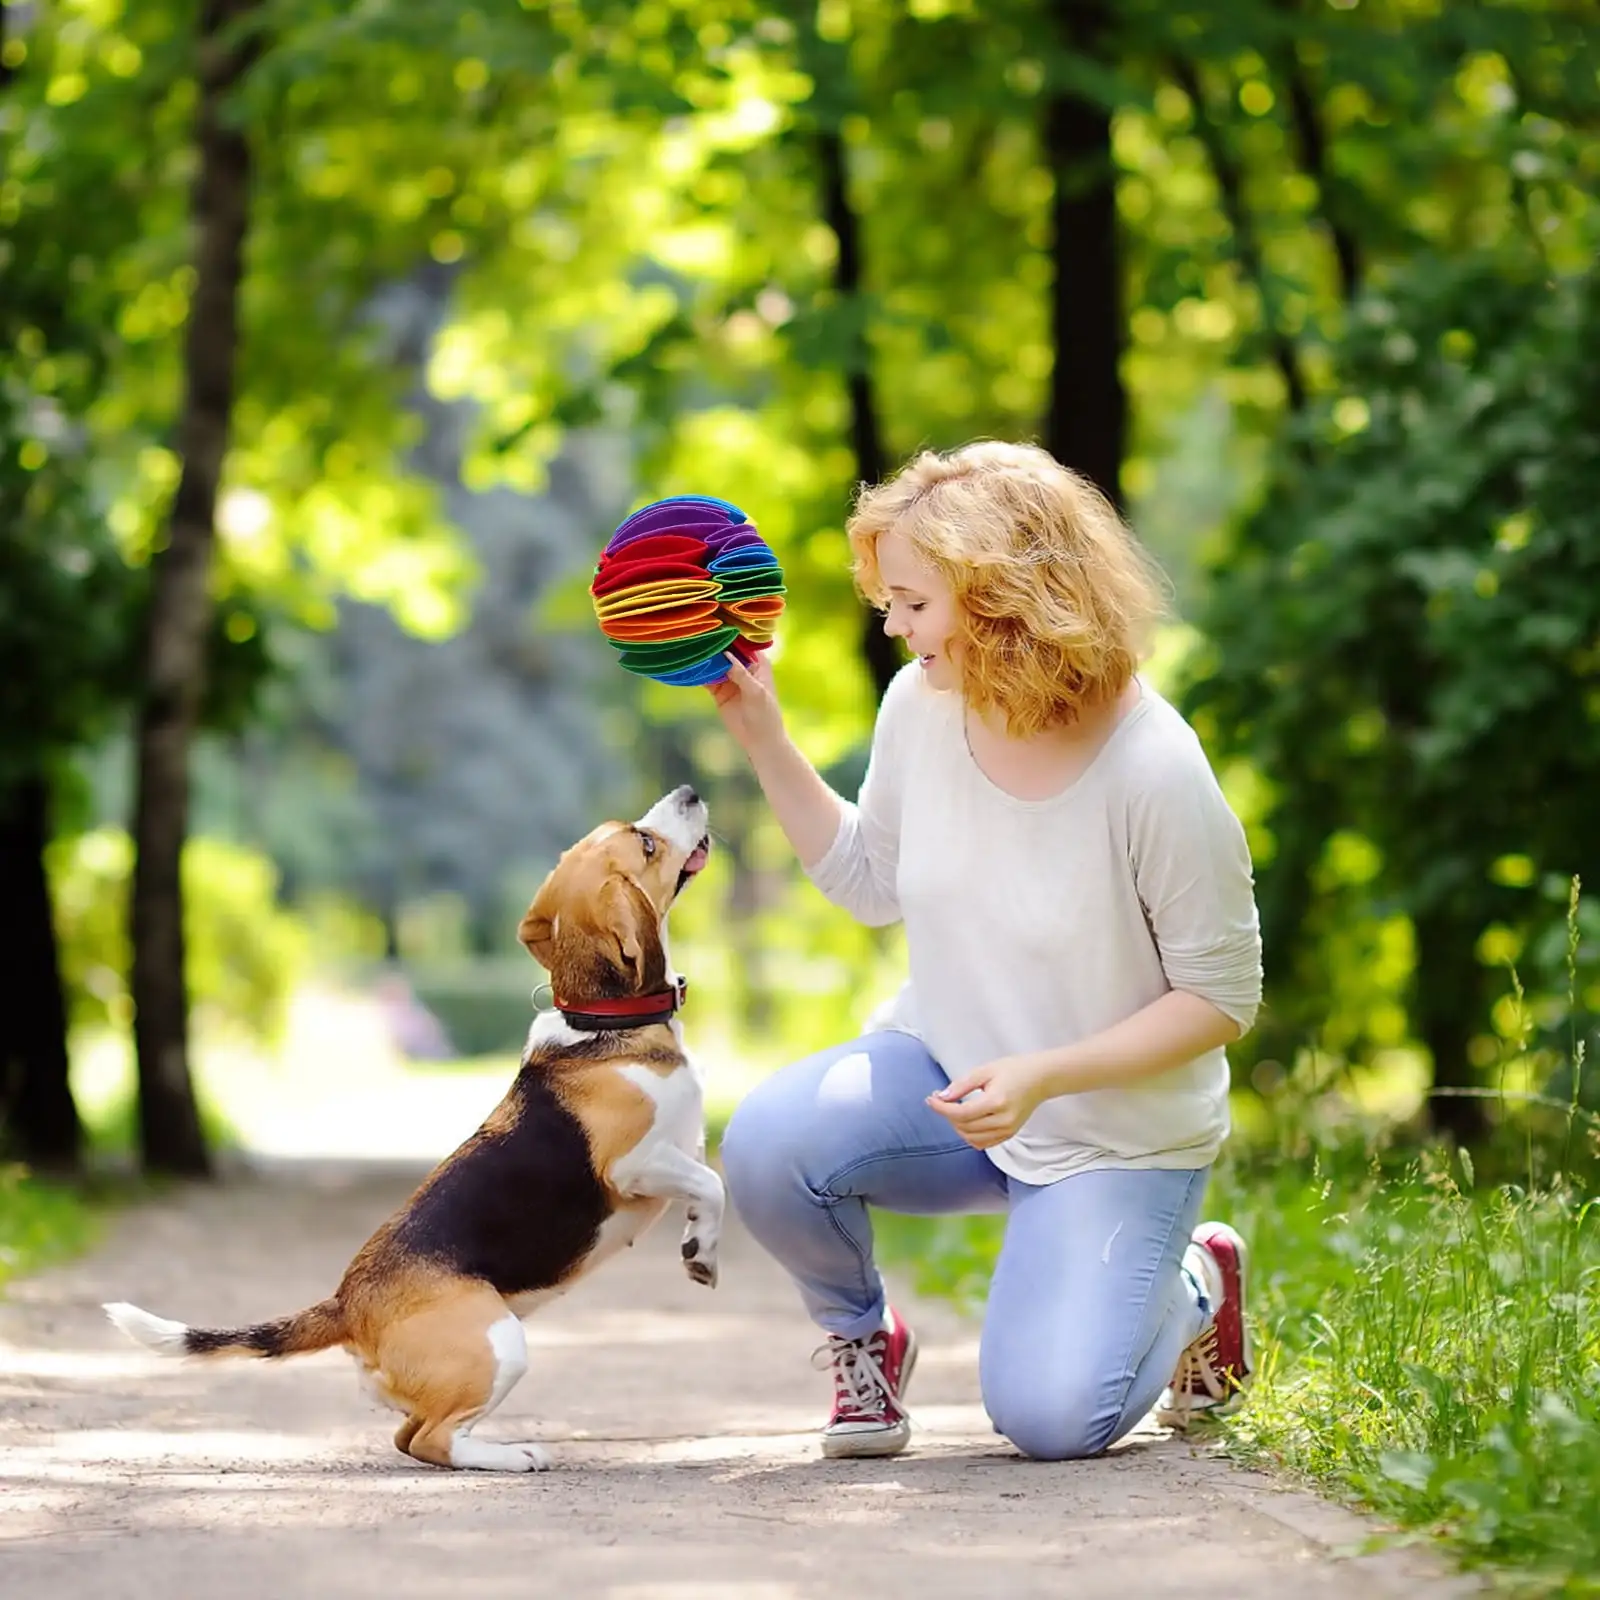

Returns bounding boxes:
[810,662,1261,1184]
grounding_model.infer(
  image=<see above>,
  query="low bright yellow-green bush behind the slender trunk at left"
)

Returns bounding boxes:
[48,829,306,1042]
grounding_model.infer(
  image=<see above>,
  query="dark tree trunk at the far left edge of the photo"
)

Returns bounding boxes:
[0,776,83,1170]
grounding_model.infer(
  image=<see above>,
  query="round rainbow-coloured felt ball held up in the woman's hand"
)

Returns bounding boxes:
[589,494,784,685]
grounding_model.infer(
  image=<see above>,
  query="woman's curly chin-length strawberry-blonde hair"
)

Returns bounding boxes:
[846,440,1166,738]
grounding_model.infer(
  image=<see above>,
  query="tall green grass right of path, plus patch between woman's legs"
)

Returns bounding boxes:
[878,1154,1600,1597]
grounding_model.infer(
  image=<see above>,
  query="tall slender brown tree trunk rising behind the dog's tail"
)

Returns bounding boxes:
[131,0,256,1176]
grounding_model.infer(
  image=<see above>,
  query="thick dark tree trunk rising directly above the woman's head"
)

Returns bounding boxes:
[1043,0,1128,504]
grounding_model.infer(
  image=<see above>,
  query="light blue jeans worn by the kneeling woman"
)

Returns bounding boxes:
[722,1034,1210,1461]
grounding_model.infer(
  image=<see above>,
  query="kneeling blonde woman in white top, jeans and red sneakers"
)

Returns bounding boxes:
[712,443,1261,1459]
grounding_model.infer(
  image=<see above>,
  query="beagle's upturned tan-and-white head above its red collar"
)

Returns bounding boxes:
[517,784,710,1000]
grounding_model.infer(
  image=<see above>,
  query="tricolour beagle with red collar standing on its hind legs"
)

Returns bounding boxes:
[106,786,723,1472]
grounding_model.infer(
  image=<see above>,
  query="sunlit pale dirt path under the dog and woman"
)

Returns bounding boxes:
[0,1162,1467,1600]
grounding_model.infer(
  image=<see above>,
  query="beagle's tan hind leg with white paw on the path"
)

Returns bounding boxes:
[381,1288,550,1472]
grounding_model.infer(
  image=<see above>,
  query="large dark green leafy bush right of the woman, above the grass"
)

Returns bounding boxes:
[1186,246,1600,1075]
